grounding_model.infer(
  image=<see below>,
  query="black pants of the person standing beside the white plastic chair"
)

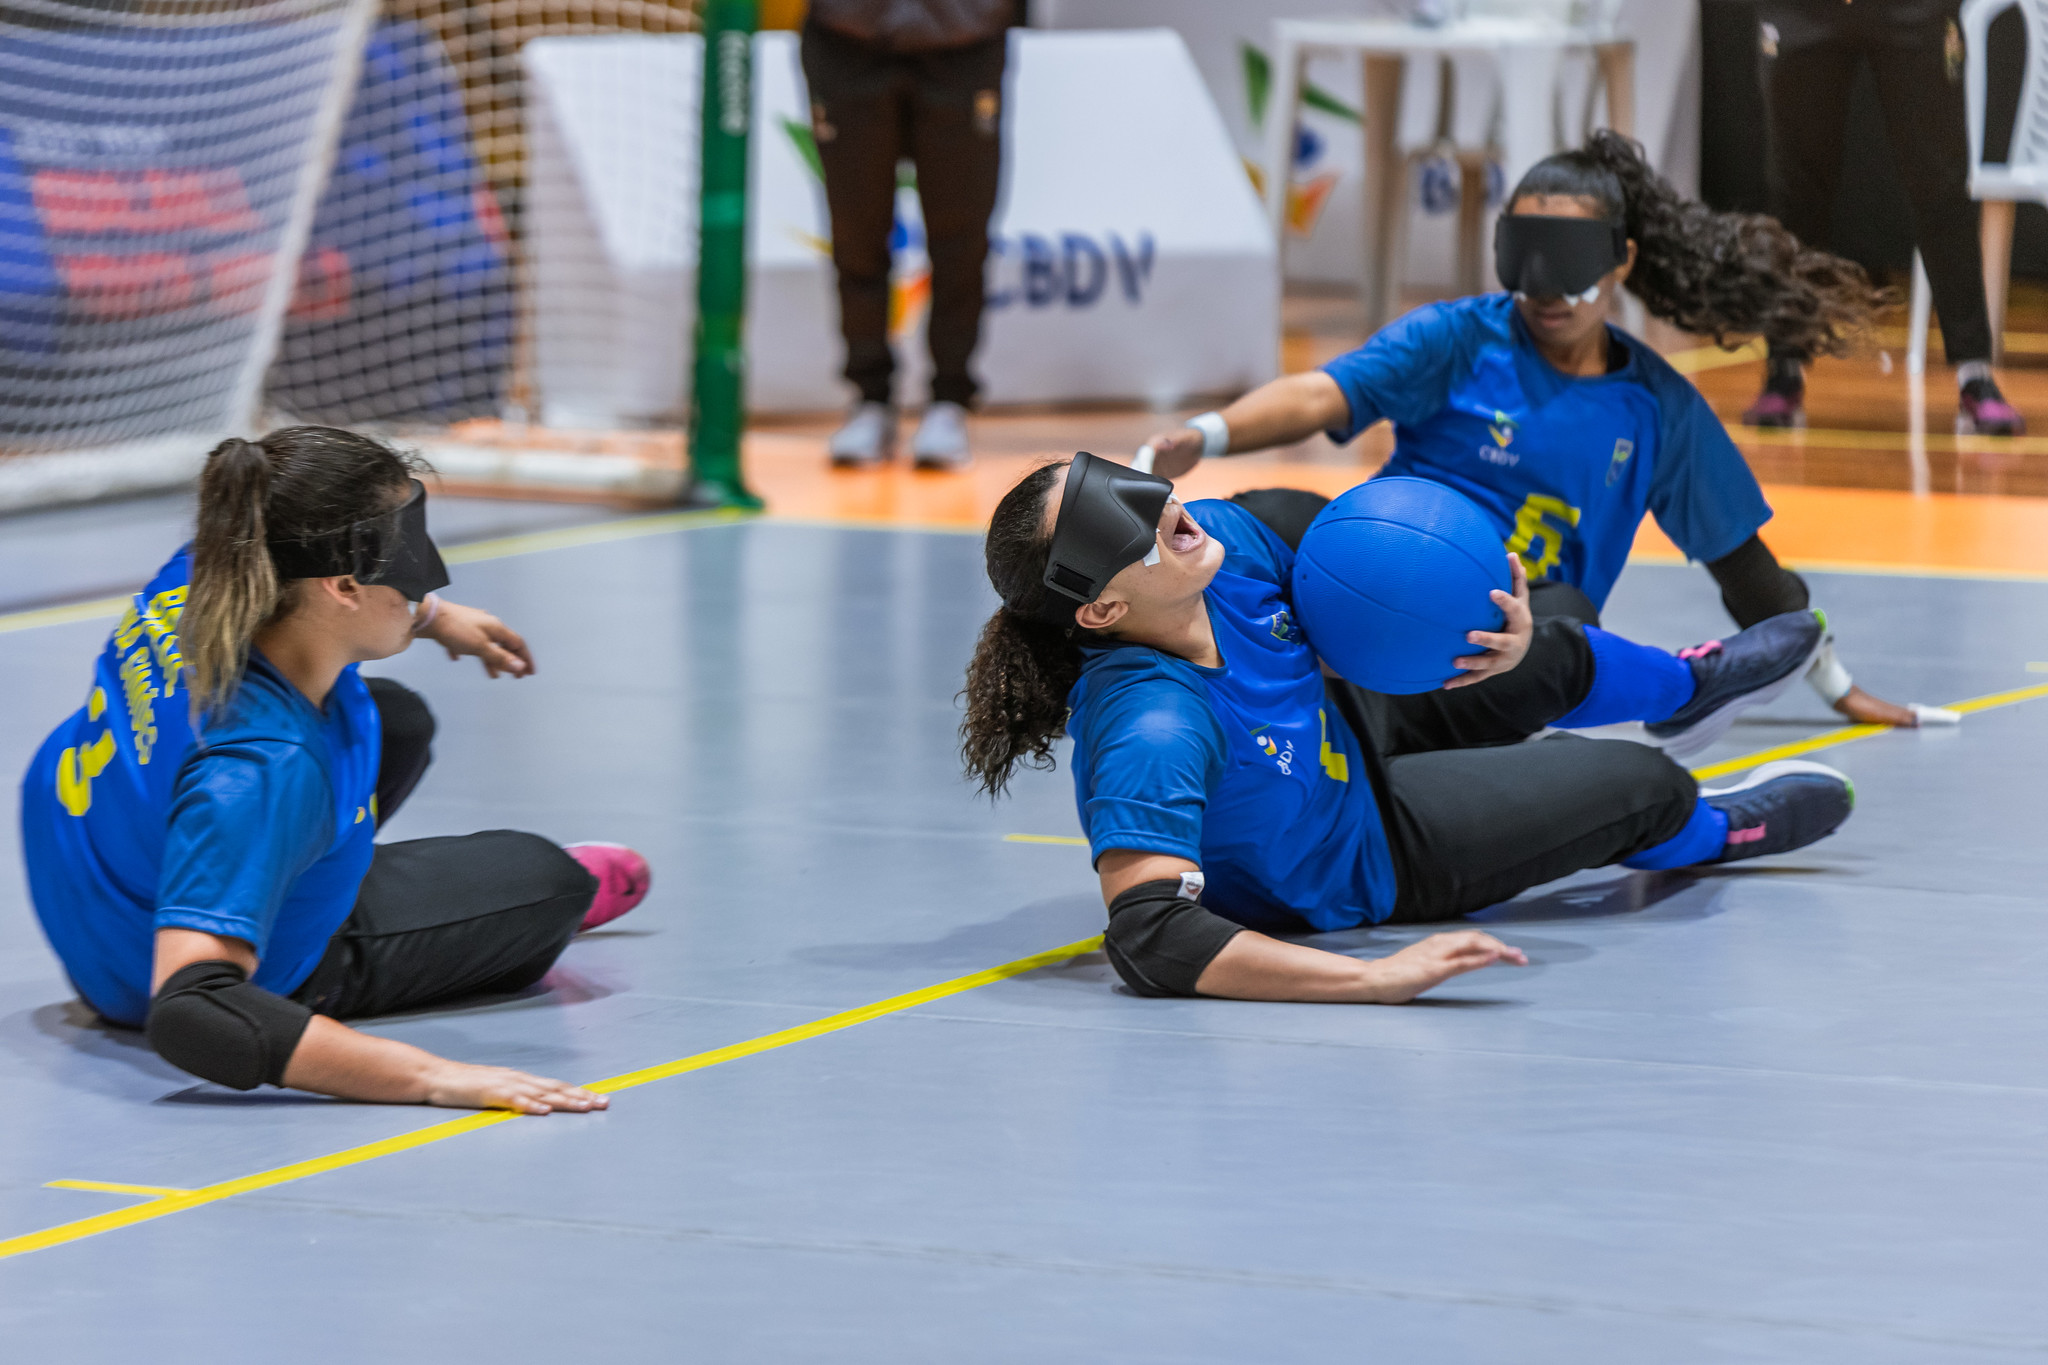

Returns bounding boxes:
[1761,0,1991,364]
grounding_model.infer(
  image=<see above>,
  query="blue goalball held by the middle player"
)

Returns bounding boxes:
[1294,477,1511,692]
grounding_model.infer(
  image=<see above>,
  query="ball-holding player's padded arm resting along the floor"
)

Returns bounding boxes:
[1096,849,1528,1005]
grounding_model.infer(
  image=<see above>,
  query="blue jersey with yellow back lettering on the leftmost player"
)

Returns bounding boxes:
[20,551,381,1025]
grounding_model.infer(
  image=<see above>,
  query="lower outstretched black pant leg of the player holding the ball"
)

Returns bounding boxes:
[1380,735,1695,921]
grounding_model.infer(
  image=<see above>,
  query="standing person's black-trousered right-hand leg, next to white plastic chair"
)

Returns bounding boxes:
[1868,20,1991,377]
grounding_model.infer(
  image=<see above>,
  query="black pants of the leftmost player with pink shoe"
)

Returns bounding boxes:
[293,677,598,1019]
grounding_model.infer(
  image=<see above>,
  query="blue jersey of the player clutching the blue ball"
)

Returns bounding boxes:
[1067,499,1395,929]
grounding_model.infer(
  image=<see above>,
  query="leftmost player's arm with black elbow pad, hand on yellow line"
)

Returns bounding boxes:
[150,929,610,1113]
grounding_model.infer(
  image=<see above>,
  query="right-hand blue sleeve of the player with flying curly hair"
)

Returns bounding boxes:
[1636,358,1772,563]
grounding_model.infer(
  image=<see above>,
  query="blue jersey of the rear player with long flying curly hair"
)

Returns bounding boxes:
[1323,295,1772,604]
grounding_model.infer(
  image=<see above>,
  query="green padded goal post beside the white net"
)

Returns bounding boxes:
[684,0,762,508]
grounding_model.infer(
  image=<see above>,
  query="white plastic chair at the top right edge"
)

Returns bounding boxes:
[1907,0,2048,375]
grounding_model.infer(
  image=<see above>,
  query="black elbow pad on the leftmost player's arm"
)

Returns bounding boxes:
[145,962,313,1091]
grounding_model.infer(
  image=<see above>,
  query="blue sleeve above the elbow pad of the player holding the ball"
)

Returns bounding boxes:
[1079,677,1225,864]
